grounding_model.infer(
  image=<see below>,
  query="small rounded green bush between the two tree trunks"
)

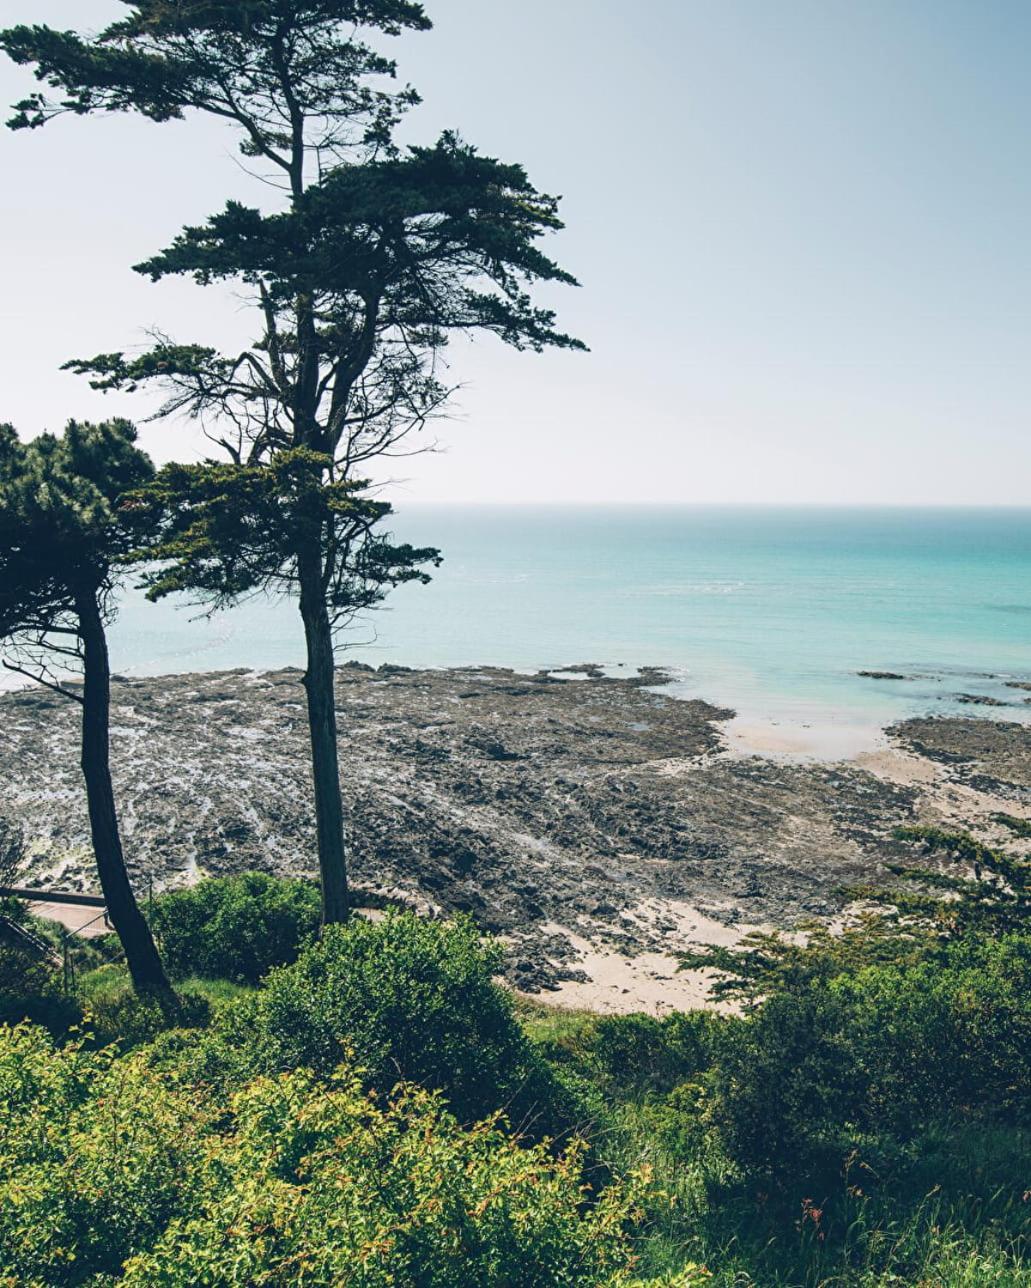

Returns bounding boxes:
[148,872,320,984]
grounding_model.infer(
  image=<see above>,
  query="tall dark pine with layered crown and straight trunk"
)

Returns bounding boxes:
[0,0,583,921]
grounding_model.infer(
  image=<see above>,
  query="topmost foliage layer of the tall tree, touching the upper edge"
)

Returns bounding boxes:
[0,0,429,142]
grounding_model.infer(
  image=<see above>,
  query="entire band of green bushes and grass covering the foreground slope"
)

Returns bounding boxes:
[0,833,1031,1288]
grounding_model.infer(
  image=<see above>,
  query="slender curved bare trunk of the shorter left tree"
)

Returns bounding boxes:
[76,590,171,998]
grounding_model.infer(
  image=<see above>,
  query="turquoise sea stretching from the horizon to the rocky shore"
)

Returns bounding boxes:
[18,506,1031,753]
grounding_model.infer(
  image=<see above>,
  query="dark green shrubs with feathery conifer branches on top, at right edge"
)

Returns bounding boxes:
[680,828,1031,1184]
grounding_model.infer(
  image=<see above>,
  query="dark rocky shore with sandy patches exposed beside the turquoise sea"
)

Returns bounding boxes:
[0,665,1031,1001]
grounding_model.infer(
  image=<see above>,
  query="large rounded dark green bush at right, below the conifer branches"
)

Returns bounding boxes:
[708,936,1031,1180]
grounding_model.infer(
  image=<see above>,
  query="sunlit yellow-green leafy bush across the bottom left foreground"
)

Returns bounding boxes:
[0,1027,643,1288]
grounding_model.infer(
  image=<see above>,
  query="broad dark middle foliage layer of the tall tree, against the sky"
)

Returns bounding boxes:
[118,133,583,345]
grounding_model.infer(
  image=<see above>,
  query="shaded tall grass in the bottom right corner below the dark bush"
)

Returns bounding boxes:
[602,1101,1031,1288]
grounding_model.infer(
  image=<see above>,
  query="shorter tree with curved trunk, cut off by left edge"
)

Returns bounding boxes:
[0,420,170,994]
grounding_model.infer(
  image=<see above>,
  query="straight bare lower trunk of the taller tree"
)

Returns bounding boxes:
[298,546,351,926]
